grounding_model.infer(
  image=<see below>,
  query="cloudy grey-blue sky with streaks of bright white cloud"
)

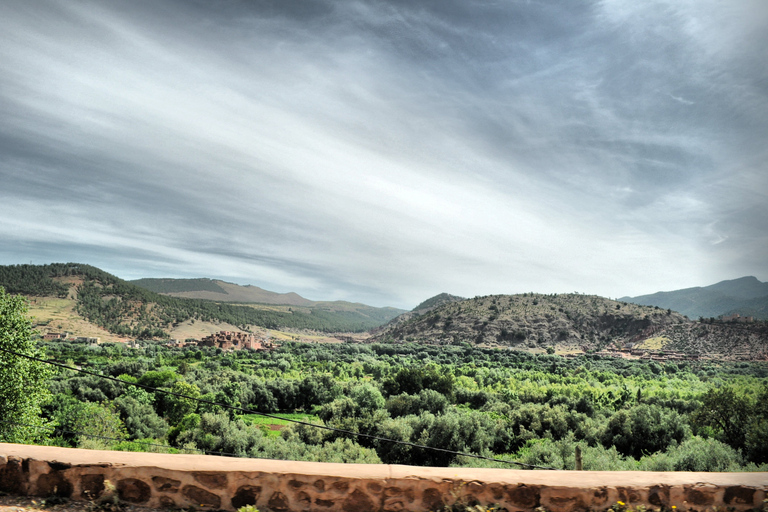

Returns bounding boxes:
[0,0,768,309]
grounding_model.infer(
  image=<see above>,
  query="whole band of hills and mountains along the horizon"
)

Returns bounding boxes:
[0,263,768,360]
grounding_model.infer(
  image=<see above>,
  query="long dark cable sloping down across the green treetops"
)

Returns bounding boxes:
[0,347,557,470]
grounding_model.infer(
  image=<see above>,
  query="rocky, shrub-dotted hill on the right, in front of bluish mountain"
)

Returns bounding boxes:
[374,293,768,359]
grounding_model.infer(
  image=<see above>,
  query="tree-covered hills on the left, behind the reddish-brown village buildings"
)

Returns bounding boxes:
[0,263,402,338]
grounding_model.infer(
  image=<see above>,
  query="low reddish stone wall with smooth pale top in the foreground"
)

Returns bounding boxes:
[0,443,768,512]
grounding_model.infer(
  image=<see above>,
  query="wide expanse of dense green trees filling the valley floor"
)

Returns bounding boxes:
[21,334,768,470]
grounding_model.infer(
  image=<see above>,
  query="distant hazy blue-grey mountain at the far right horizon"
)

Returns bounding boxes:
[619,276,768,320]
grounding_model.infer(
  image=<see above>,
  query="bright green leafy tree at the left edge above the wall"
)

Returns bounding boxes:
[0,287,52,443]
